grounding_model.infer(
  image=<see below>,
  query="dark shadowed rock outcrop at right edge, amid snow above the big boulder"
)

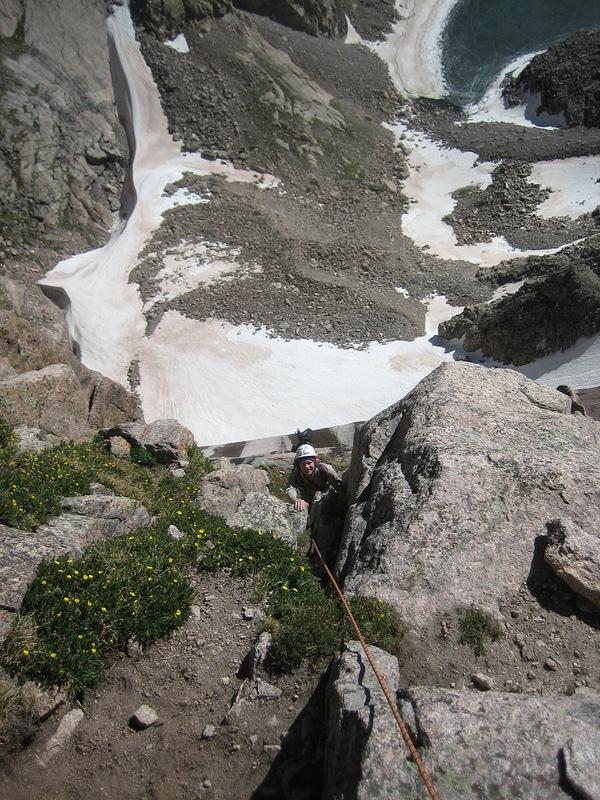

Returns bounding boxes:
[439,237,600,366]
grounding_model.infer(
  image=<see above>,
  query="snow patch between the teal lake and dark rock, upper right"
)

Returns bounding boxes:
[466,50,566,130]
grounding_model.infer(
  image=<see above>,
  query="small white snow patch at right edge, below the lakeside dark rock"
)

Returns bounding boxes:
[527,156,600,219]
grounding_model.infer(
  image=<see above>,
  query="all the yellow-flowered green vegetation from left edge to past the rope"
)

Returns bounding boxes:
[0,416,400,693]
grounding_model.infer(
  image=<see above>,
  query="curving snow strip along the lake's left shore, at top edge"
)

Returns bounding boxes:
[367,0,458,98]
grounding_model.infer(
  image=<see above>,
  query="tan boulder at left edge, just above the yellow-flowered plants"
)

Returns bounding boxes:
[0,364,92,441]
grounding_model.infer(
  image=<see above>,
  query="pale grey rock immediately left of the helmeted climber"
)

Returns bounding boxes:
[195,461,307,544]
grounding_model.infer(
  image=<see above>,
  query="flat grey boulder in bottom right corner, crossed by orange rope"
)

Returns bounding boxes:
[322,643,600,800]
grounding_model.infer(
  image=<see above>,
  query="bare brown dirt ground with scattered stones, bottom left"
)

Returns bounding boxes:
[0,575,320,800]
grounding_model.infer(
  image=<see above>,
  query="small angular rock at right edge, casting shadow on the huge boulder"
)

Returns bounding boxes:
[544,519,600,608]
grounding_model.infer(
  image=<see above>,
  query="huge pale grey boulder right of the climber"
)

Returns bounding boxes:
[336,363,600,649]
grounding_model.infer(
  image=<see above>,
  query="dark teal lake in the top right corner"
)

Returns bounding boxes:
[442,0,600,105]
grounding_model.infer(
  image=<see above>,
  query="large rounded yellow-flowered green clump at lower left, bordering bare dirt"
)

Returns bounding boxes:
[2,530,193,692]
